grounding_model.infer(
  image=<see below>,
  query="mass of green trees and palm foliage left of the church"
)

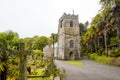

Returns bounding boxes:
[0,31,53,80]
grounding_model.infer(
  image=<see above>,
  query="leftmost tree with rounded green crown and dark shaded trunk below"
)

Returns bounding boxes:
[0,31,19,80]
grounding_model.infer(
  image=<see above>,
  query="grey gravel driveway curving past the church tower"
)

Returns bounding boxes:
[55,60,120,80]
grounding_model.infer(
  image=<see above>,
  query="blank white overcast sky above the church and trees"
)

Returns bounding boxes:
[0,0,100,37]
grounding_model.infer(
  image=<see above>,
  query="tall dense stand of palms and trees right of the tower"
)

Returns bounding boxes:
[81,0,120,57]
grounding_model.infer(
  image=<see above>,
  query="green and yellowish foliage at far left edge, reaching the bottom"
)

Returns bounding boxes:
[0,31,19,80]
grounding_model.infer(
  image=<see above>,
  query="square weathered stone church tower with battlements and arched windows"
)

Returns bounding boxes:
[57,13,80,60]
